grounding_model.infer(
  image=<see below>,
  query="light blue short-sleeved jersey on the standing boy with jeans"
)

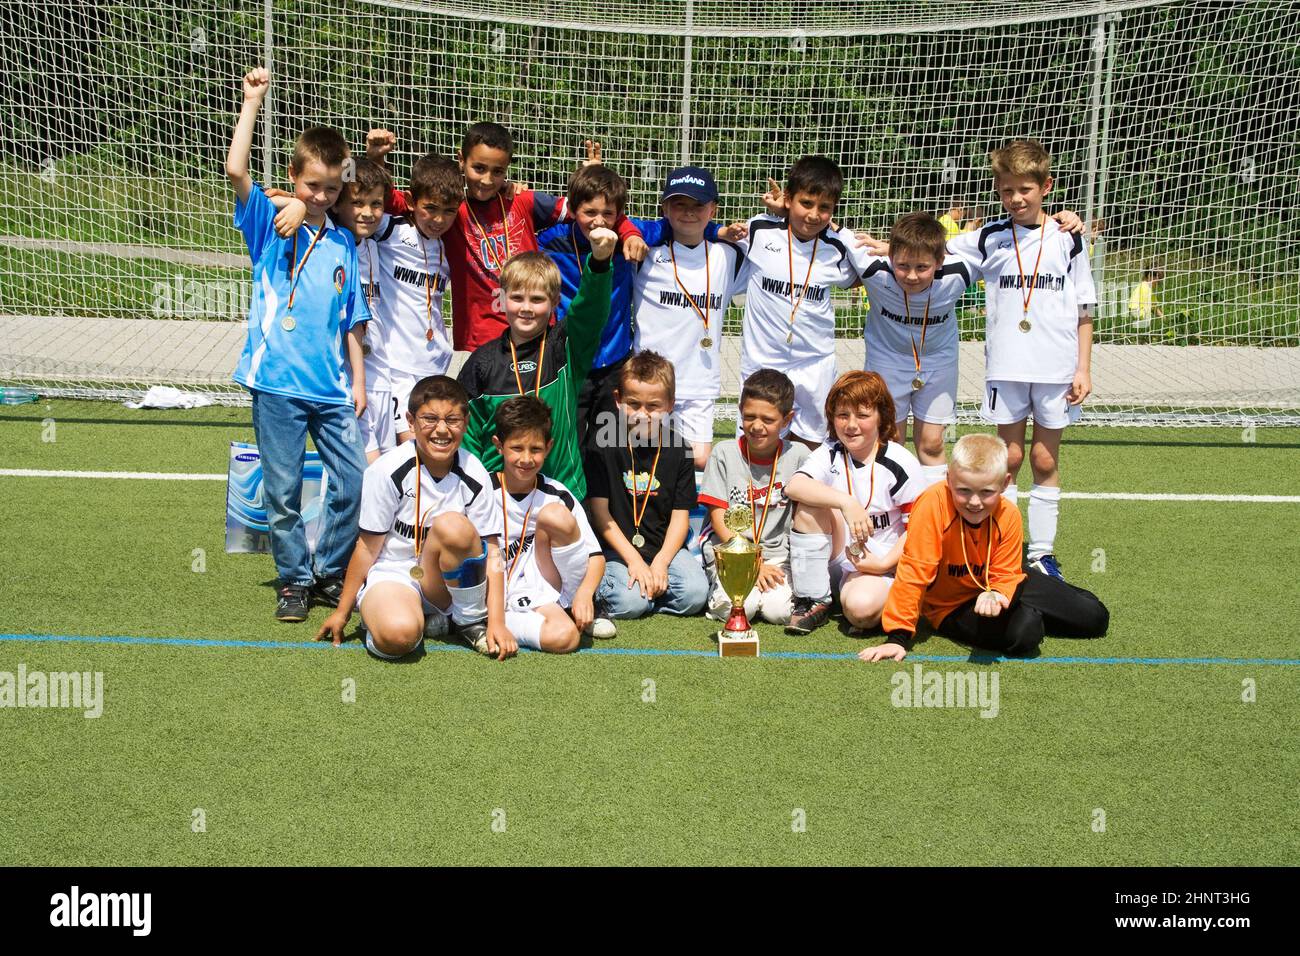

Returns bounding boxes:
[234,183,371,405]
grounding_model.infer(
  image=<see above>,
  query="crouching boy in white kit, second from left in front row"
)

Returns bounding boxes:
[491,395,605,654]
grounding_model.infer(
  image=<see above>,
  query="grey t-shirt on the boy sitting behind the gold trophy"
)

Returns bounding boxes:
[699,436,809,566]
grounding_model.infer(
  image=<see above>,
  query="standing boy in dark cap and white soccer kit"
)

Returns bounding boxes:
[633,166,749,470]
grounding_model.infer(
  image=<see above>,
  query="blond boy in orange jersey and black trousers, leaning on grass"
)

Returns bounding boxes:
[858,434,1110,661]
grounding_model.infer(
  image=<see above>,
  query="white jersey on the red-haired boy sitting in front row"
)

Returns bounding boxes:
[796,441,926,554]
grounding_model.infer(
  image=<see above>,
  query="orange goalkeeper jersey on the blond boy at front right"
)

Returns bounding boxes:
[880,481,1024,635]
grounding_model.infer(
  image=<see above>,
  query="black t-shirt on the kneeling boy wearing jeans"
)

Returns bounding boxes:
[586,432,698,563]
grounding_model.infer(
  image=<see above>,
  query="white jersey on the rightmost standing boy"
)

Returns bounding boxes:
[948,219,1097,384]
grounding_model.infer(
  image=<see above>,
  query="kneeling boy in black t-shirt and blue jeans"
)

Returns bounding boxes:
[586,351,709,619]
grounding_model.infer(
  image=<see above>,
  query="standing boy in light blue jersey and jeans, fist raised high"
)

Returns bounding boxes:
[226,68,369,622]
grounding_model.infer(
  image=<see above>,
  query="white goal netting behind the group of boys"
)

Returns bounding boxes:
[0,0,1300,421]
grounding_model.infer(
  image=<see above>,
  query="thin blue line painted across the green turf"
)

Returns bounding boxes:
[0,633,1300,667]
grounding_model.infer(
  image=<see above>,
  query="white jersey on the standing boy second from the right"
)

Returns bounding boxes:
[853,250,980,372]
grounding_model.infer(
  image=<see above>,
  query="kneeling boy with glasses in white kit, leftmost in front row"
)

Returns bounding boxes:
[316,375,517,661]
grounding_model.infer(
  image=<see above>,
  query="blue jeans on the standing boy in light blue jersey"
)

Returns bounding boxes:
[252,390,365,587]
